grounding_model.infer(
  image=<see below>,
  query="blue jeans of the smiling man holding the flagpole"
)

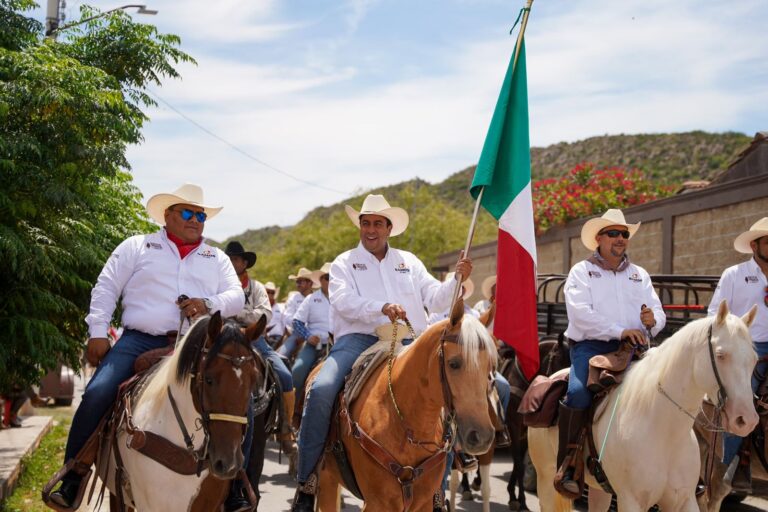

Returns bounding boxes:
[297,333,412,483]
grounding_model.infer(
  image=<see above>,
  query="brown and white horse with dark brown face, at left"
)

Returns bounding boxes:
[107,313,265,512]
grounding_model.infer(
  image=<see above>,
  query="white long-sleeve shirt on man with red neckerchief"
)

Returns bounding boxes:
[85,229,245,338]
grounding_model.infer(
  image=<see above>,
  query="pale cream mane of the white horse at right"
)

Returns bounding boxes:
[619,315,750,411]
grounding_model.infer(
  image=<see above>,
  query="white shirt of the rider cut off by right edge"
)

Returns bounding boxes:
[708,258,768,343]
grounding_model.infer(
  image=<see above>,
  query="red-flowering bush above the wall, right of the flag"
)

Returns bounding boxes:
[533,163,674,234]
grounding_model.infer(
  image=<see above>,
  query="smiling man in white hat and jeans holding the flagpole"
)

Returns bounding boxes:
[291,195,472,512]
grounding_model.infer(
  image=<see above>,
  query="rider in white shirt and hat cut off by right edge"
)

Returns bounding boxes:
[708,217,768,492]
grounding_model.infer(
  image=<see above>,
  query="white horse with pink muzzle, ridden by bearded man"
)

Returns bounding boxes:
[528,301,758,512]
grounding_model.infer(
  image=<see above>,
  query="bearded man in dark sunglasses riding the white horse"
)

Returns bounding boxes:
[555,209,666,499]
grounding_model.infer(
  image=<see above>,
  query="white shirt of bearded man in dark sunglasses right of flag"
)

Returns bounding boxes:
[565,260,667,341]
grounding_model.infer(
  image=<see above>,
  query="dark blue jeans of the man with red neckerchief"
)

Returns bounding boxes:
[64,329,168,462]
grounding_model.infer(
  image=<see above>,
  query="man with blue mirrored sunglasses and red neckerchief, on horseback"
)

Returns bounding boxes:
[50,184,243,509]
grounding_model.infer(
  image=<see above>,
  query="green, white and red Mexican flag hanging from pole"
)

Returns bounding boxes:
[470,42,539,379]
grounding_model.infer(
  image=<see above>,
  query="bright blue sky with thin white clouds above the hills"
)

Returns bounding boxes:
[35,0,768,240]
